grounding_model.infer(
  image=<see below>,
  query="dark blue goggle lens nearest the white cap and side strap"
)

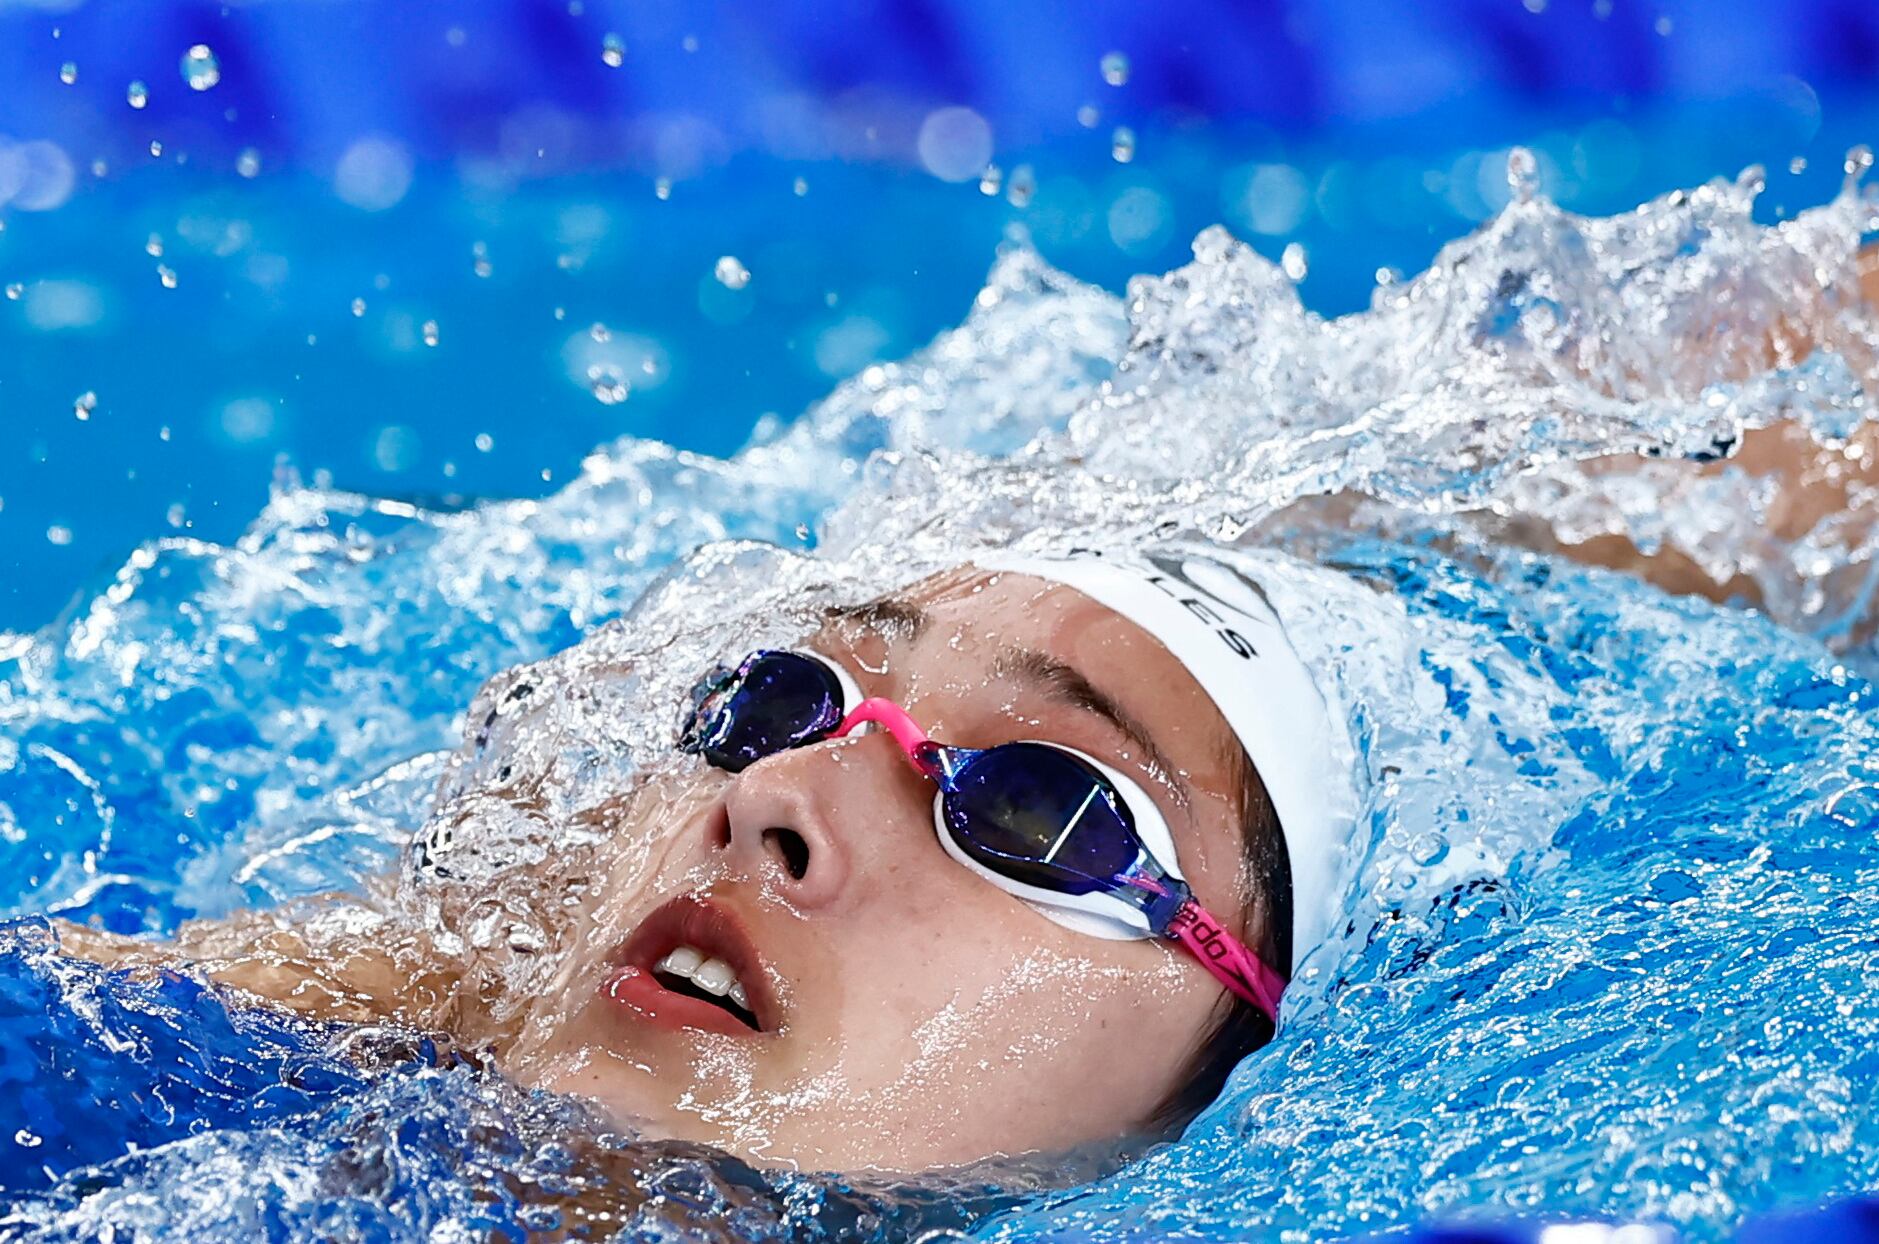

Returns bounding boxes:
[940,742,1142,894]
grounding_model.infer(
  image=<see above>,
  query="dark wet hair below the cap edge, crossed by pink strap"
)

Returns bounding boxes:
[1148,744,1293,1135]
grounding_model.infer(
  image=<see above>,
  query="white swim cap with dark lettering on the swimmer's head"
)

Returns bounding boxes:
[975,539,1353,970]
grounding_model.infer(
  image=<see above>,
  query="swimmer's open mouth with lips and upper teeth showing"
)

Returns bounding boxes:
[601,896,776,1037]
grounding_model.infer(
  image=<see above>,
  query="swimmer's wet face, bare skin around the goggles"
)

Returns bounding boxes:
[504,571,1246,1171]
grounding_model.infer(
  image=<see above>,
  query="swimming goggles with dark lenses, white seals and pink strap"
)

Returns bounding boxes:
[678,650,1285,1022]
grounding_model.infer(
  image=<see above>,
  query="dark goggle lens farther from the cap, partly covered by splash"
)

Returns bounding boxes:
[678,652,842,772]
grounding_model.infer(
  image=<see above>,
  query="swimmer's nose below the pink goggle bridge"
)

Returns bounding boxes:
[716,737,932,908]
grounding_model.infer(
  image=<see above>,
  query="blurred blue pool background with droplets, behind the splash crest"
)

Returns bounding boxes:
[11,0,1879,630]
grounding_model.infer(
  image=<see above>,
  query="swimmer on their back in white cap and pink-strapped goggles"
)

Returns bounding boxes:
[64,545,1351,1171]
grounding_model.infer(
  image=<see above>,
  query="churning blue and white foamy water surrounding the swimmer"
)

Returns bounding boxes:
[0,160,1879,1240]
